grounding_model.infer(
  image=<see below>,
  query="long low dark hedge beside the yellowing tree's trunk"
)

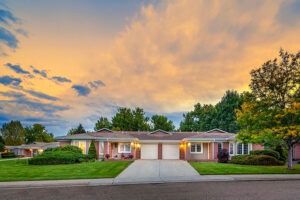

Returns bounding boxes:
[230,155,284,166]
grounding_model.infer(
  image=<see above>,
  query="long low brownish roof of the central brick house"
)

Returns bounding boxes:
[56,129,236,141]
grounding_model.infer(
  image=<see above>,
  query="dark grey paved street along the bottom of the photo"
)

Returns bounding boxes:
[0,180,300,200]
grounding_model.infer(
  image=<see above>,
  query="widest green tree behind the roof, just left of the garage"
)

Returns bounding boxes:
[112,108,150,131]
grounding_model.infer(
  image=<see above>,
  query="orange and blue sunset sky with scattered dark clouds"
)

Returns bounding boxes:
[0,0,300,136]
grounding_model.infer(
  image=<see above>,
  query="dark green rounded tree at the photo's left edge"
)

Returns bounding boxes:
[1,121,25,146]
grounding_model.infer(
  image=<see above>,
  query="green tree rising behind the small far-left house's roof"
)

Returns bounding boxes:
[25,124,54,144]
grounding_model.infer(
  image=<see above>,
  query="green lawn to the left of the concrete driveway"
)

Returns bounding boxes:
[0,159,132,181]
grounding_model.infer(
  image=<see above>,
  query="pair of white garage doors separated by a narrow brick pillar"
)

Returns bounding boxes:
[141,144,179,159]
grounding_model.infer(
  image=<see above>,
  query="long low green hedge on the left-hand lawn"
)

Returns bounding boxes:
[28,151,89,165]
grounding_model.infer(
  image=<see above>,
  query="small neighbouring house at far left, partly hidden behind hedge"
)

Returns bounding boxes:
[5,142,60,157]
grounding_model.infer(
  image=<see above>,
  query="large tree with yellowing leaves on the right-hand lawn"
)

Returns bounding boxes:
[237,49,300,169]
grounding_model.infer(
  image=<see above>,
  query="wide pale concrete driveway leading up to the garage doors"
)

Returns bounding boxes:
[114,160,200,183]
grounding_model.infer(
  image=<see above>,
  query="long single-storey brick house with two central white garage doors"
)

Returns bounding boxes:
[56,128,263,161]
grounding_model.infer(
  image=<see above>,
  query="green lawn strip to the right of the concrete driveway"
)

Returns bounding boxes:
[190,162,300,175]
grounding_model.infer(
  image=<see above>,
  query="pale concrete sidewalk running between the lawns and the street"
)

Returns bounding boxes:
[0,174,300,188]
